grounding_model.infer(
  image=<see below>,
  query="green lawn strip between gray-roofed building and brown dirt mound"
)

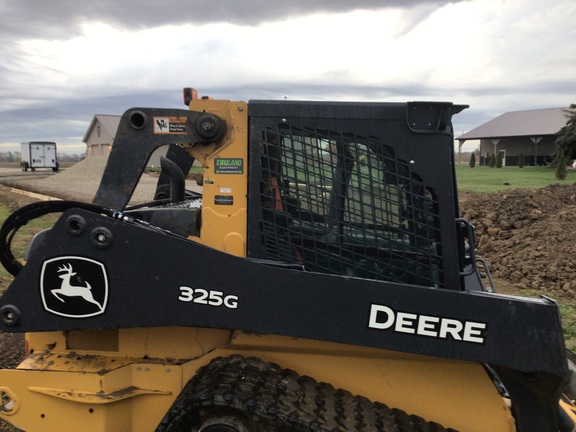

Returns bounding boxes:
[456,165,576,193]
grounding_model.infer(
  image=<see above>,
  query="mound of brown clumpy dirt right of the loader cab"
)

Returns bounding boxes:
[460,184,576,295]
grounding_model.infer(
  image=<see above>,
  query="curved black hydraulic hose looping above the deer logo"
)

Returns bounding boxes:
[0,201,117,276]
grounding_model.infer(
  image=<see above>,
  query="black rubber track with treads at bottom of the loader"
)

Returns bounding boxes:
[156,355,456,432]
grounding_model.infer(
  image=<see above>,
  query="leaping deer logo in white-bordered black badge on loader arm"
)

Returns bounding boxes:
[40,256,108,318]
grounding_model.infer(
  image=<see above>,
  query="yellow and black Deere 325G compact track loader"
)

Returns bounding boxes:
[0,89,574,432]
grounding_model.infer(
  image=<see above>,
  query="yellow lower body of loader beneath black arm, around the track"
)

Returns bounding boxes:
[0,328,515,432]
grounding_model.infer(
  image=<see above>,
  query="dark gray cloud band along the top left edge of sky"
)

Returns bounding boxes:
[0,0,465,39]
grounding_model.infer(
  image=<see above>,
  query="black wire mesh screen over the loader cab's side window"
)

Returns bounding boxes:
[261,126,443,287]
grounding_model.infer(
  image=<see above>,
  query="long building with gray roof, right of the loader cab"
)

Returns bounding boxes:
[456,108,568,165]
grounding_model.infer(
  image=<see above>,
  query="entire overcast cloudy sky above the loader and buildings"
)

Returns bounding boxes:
[0,0,576,153]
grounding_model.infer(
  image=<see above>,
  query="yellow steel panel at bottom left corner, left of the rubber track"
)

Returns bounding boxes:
[0,364,182,432]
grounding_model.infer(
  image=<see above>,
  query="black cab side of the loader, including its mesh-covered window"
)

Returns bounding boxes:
[248,101,462,289]
